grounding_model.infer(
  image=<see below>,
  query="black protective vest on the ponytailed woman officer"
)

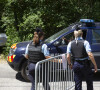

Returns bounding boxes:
[28,42,45,63]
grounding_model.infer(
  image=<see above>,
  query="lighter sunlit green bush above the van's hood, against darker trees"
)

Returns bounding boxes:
[2,9,44,54]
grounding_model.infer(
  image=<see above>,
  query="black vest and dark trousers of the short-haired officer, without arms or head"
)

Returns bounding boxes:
[71,40,93,90]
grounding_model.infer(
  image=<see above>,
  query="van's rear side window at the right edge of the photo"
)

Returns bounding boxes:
[92,29,100,44]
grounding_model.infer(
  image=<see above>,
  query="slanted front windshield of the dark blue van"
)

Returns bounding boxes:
[45,28,69,43]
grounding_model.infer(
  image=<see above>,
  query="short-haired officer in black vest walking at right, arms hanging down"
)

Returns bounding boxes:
[67,30,97,90]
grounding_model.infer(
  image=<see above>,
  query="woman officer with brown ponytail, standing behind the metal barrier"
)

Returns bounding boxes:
[25,29,50,90]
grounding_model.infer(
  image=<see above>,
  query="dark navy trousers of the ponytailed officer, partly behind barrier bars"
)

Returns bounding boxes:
[28,63,50,90]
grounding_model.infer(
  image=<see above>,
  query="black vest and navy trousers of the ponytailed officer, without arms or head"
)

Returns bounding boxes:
[28,42,50,90]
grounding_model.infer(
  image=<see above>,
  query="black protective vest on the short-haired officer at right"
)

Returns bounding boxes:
[71,40,88,59]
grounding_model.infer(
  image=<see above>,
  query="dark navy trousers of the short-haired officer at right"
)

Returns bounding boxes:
[73,61,93,90]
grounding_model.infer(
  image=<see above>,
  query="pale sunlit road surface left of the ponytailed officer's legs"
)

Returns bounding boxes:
[0,61,31,90]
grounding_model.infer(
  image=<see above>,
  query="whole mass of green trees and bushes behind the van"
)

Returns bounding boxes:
[0,0,100,53]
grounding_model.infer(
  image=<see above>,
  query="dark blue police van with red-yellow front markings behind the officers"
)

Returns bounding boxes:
[7,19,100,81]
